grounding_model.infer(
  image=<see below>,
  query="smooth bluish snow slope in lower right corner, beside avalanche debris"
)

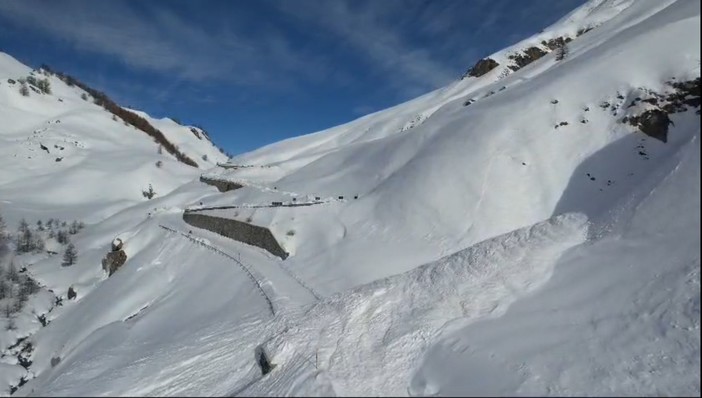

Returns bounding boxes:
[411,132,700,396]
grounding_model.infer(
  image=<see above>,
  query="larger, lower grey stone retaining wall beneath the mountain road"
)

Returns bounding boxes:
[183,211,289,260]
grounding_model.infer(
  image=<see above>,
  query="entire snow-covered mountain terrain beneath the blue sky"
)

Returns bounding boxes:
[0,0,700,396]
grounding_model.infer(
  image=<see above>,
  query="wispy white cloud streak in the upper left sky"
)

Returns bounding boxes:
[0,0,327,85]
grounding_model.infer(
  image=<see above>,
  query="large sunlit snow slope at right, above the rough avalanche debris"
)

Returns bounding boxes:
[203,0,700,293]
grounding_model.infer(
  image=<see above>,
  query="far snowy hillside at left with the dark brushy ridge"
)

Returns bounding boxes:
[0,53,226,225]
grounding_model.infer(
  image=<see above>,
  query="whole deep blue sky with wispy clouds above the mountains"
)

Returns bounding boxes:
[0,0,584,154]
